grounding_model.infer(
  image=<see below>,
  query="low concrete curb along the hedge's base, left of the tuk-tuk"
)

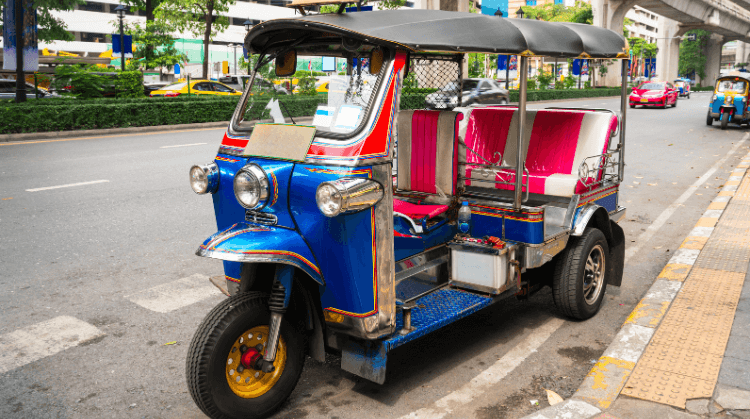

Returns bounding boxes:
[0,121,229,143]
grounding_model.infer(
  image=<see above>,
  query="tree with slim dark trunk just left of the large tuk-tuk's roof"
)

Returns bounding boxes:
[156,0,234,79]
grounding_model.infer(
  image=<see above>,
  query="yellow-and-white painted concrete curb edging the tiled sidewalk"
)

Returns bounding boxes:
[524,149,750,419]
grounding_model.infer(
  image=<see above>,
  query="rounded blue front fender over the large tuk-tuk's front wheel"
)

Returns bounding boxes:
[195,222,324,285]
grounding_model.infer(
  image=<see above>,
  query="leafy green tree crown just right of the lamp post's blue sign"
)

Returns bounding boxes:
[127,20,187,69]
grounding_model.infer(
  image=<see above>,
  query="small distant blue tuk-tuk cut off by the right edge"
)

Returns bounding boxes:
[706,72,750,129]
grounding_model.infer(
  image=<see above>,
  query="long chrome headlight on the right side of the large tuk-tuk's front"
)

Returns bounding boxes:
[315,178,383,217]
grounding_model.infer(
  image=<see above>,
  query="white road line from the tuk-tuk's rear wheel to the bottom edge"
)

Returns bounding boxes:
[401,318,565,419]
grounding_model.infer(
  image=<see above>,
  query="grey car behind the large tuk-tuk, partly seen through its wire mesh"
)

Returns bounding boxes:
[425,78,510,109]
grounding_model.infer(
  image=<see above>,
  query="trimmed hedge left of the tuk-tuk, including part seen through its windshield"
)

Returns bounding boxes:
[0,96,326,134]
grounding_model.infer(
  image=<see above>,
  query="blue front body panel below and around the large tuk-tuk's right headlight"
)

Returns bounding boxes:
[289,164,383,317]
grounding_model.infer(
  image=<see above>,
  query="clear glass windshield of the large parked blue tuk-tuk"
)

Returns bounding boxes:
[235,56,387,134]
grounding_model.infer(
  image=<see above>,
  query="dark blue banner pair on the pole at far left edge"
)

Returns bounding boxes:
[3,0,39,72]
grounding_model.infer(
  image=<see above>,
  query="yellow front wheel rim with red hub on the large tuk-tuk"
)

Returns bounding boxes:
[226,326,286,399]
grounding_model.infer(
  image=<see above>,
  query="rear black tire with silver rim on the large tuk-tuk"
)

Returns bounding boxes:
[552,228,609,320]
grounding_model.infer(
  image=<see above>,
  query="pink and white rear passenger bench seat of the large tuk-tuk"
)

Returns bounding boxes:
[456,108,617,197]
